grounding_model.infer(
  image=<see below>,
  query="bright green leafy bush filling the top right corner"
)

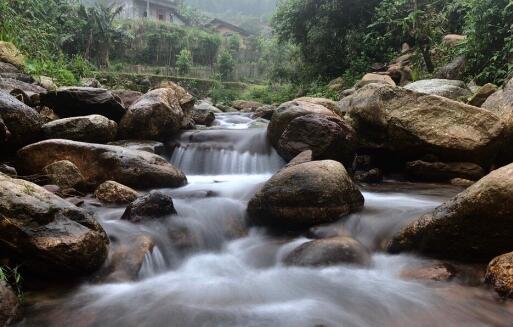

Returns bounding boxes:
[465,0,513,84]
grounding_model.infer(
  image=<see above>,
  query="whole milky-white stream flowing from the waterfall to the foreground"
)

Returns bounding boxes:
[20,114,513,327]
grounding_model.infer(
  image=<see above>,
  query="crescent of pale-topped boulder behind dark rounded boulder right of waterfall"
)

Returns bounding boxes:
[267,100,338,146]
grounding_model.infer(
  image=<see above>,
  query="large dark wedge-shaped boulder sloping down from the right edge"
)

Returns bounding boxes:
[389,165,513,262]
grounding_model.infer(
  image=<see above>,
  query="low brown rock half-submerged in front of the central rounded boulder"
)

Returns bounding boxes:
[284,236,371,267]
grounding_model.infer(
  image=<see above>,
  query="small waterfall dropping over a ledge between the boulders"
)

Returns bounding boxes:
[170,128,284,175]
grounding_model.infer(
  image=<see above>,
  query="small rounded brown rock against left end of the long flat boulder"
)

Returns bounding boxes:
[43,160,84,189]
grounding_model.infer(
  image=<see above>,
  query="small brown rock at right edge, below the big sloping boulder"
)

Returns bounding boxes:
[485,253,513,298]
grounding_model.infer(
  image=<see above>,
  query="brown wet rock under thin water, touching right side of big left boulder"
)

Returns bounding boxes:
[104,235,155,283]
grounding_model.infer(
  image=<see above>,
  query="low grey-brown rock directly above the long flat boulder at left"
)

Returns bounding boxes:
[42,115,118,143]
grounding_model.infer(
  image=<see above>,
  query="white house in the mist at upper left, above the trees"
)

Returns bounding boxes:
[107,0,189,25]
